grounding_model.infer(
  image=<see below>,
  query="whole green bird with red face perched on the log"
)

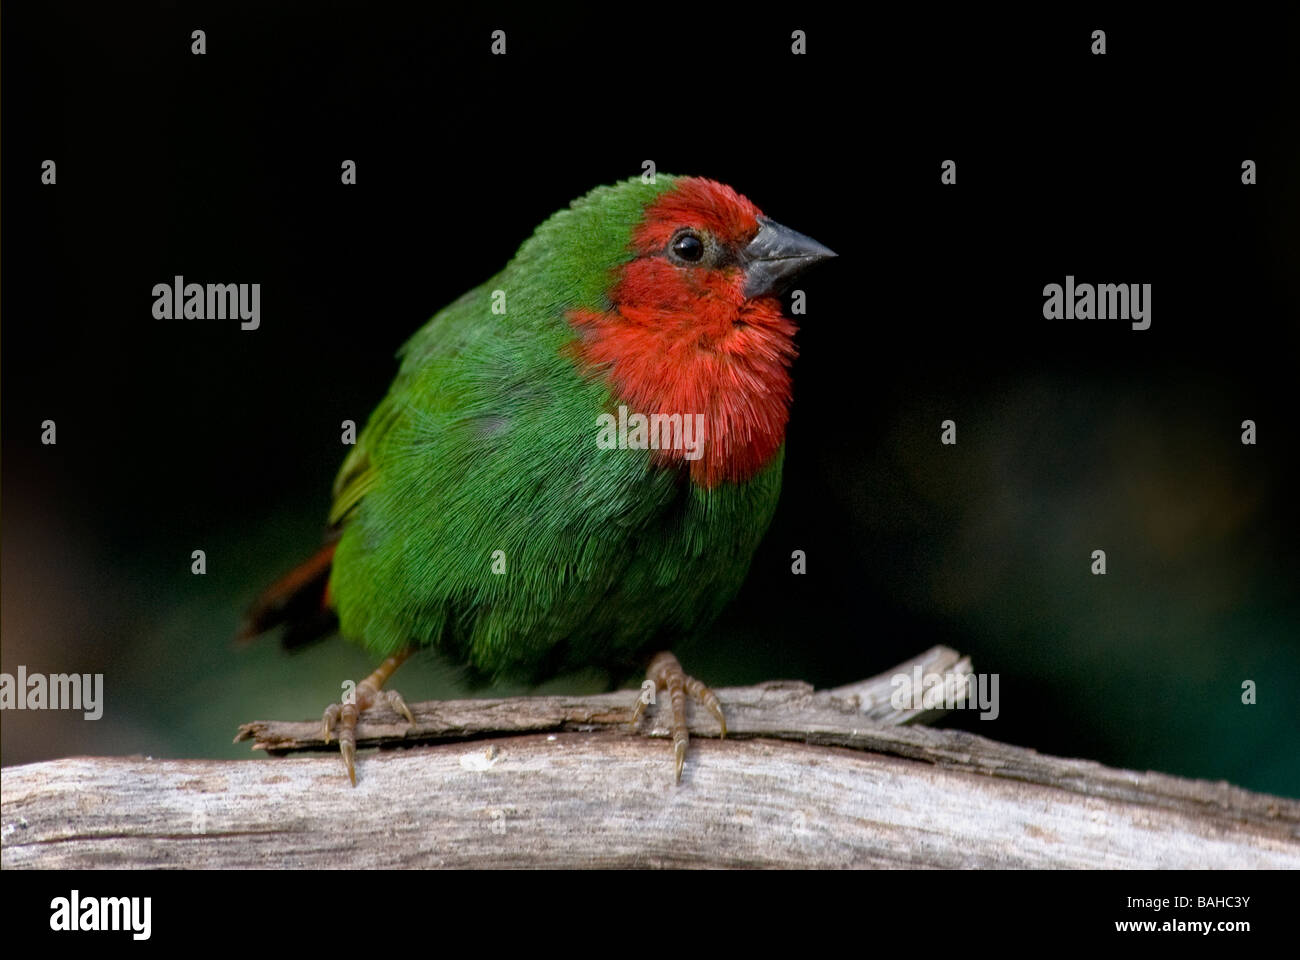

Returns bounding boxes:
[241,174,835,784]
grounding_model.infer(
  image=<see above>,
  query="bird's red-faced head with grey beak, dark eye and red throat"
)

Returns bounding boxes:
[548,174,835,488]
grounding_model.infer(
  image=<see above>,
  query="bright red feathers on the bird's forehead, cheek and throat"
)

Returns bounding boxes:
[568,178,796,488]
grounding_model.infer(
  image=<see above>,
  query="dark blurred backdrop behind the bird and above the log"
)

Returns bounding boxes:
[0,4,1300,796]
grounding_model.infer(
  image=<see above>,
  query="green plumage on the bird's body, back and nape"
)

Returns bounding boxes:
[330,174,781,680]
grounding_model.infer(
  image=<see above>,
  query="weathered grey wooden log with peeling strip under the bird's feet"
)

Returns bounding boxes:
[0,648,1300,869]
